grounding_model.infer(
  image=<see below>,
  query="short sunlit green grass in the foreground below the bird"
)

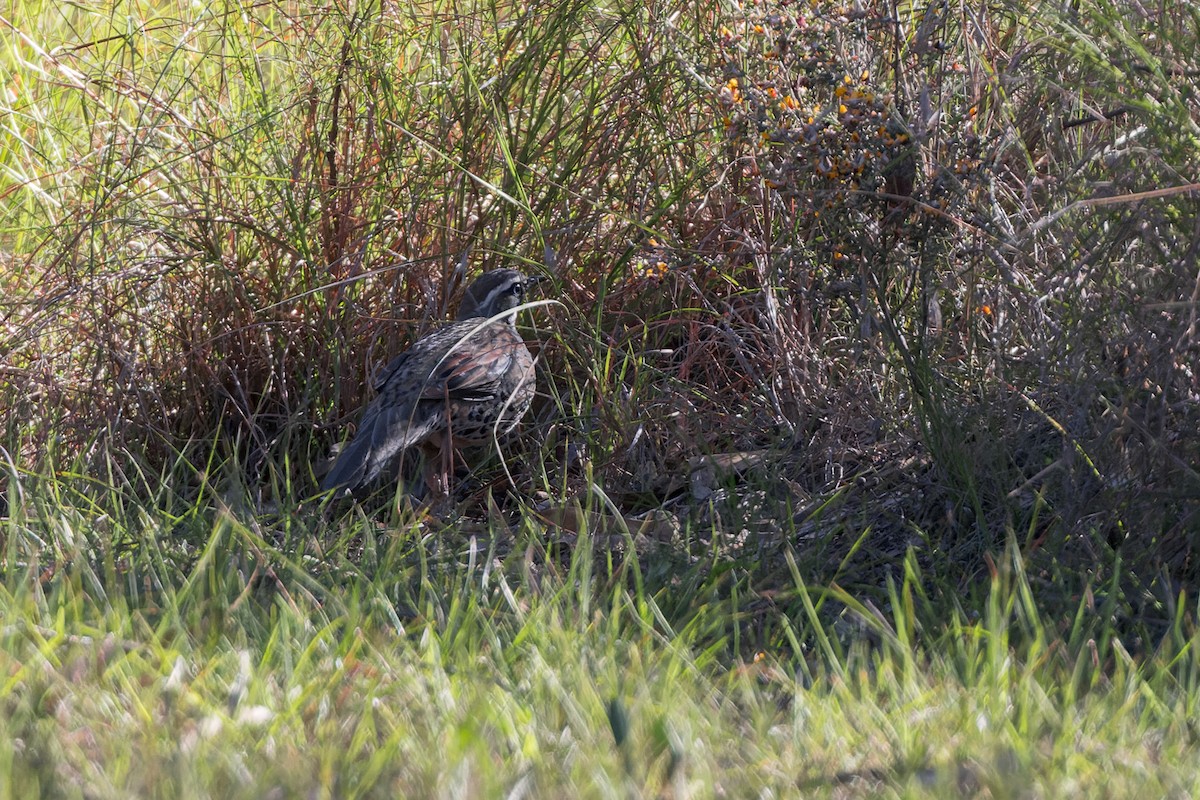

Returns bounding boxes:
[7,479,1200,796]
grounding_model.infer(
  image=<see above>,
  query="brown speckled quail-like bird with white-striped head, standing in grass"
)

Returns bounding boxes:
[320,269,542,495]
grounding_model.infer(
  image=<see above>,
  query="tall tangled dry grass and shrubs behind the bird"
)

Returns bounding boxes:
[0,0,1200,599]
